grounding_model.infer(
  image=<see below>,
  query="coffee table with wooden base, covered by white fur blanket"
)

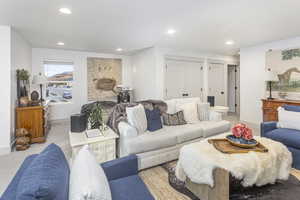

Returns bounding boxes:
[176,133,292,200]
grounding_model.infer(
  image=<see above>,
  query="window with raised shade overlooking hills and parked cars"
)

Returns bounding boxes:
[44,61,74,102]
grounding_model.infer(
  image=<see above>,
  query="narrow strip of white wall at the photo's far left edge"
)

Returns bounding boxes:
[0,26,11,155]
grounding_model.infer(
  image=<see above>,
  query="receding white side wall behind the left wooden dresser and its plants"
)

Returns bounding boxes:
[11,28,32,142]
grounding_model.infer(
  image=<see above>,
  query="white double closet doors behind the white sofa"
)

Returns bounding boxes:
[165,59,203,99]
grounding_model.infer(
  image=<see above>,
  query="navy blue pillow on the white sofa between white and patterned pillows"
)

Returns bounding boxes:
[145,108,162,131]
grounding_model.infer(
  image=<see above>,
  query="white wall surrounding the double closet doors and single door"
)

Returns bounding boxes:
[132,47,238,100]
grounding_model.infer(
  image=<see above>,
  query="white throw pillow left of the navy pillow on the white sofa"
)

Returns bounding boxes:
[126,104,147,134]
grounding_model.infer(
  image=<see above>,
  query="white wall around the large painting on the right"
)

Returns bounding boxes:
[240,37,300,124]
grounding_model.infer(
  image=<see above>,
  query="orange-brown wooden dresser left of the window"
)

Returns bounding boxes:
[16,103,51,143]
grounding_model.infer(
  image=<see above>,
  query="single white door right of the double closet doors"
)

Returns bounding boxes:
[208,63,226,106]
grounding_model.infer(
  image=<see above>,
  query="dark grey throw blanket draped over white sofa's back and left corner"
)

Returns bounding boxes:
[107,100,168,134]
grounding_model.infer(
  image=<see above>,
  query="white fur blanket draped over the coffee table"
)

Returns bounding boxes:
[176,133,292,187]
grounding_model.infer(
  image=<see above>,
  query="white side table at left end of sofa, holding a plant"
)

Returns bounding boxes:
[69,128,119,163]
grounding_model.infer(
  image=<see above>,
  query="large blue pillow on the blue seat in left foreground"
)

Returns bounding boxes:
[16,144,70,200]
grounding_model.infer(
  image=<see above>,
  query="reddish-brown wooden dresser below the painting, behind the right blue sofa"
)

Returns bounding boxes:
[262,99,300,122]
